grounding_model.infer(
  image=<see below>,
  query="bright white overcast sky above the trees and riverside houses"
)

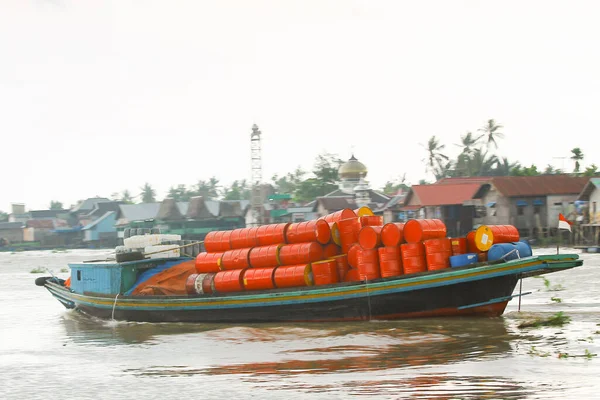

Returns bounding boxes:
[0,0,600,211]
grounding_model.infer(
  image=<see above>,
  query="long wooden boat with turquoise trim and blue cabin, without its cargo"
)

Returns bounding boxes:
[36,254,583,323]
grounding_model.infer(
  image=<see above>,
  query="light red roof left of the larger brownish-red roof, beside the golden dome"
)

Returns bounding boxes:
[404,183,481,206]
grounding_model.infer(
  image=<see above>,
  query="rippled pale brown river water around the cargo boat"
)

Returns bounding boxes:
[0,249,600,399]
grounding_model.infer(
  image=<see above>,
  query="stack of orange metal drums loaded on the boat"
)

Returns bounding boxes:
[186,211,518,294]
